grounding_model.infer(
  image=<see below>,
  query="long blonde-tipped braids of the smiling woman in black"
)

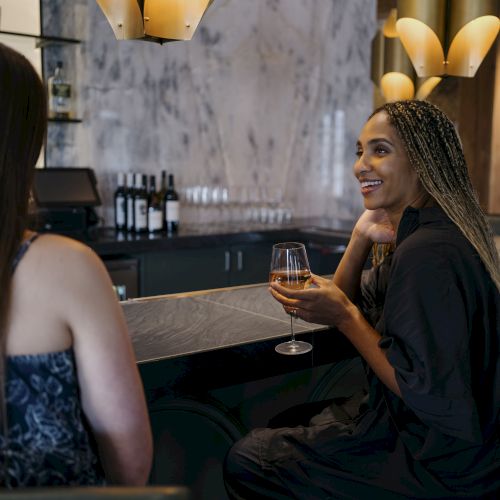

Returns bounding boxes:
[370,100,500,289]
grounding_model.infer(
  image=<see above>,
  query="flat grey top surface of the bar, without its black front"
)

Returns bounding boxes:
[121,283,326,363]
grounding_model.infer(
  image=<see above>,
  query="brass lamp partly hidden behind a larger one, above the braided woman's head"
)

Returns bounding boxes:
[371,9,441,101]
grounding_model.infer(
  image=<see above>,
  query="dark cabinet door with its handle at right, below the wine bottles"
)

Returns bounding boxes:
[140,247,229,297]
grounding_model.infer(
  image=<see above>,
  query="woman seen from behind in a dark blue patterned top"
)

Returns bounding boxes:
[0,44,152,488]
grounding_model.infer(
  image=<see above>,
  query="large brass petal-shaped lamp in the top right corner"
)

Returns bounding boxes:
[396,0,500,77]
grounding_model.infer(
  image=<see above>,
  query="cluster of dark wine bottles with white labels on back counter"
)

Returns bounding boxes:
[114,170,179,233]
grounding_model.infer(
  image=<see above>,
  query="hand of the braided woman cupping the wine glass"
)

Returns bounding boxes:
[270,274,354,327]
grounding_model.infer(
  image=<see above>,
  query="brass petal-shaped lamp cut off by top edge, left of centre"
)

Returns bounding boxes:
[96,0,214,44]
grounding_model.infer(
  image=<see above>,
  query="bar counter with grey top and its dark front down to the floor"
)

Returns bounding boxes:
[121,283,362,500]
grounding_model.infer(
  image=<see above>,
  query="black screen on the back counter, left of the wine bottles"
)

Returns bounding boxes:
[33,167,101,207]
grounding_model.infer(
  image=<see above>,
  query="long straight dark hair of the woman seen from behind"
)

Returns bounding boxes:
[0,44,47,431]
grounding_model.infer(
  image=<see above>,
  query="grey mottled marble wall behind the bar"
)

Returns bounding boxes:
[42,0,376,225]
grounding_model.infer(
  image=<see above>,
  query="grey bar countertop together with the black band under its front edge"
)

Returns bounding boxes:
[121,283,357,396]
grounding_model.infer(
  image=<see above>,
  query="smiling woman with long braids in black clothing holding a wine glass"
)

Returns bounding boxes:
[225,101,500,499]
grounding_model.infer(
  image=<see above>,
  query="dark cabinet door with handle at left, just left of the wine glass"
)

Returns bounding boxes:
[229,242,273,286]
